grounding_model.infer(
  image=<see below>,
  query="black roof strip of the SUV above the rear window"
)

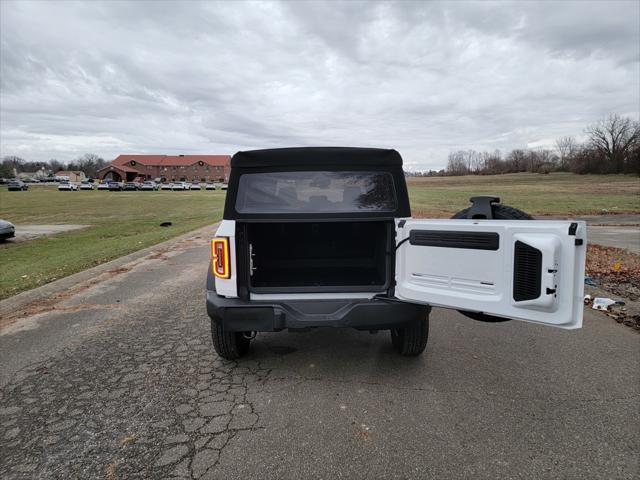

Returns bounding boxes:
[231,147,402,168]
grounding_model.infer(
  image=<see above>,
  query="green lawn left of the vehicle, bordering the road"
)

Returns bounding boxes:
[0,186,225,299]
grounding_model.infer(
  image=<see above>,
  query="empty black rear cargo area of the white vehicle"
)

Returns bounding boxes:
[247,220,394,292]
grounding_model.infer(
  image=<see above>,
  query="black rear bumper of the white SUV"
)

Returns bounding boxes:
[207,290,431,332]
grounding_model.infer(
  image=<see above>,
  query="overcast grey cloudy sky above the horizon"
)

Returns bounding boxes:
[0,0,640,169]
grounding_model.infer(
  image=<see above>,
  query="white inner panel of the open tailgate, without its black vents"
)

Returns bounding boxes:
[395,219,586,329]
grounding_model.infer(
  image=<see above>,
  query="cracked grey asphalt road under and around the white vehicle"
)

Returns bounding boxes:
[0,232,640,480]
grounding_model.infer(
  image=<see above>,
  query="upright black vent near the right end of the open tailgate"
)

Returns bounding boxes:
[513,240,542,302]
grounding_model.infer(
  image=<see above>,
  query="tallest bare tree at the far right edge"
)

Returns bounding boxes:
[585,114,640,173]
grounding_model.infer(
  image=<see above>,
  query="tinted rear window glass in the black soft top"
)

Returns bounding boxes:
[236,171,396,213]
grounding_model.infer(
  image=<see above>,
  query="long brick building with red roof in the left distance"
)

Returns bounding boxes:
[98,155,231,183]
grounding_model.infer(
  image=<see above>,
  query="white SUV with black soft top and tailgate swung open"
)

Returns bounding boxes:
[207,148,586,359]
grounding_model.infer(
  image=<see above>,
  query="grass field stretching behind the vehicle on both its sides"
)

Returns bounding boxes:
[0,173,640,299]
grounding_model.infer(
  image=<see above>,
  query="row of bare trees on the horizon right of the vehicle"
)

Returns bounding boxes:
[448,114,640,175]
